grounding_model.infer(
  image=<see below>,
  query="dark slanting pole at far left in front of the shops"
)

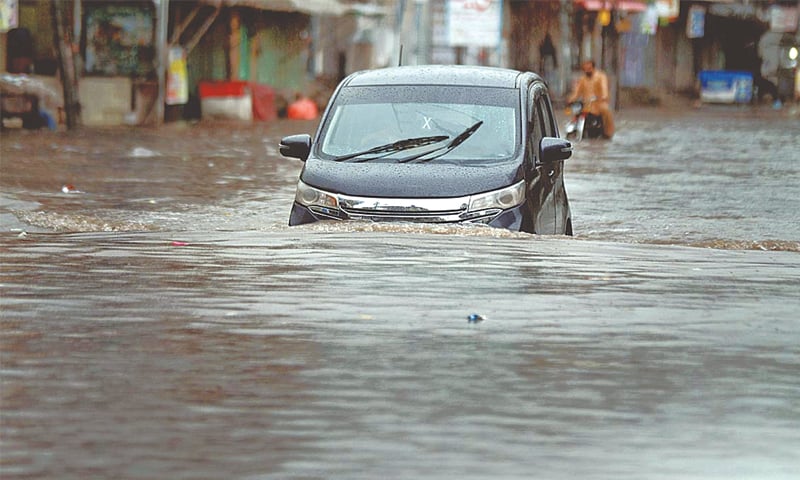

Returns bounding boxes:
[50,1,80,130]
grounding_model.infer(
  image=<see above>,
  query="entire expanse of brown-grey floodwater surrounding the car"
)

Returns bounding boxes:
[0,106,800,480]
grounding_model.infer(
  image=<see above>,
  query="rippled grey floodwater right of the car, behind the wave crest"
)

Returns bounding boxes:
[567,112,800,251]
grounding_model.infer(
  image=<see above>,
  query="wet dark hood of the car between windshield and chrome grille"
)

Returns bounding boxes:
[300,158,524,198]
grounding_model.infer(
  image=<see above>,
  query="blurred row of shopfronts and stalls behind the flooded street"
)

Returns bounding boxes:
[0,0,800,128]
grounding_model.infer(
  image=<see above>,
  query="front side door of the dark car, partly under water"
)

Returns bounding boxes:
[527,83,556,234]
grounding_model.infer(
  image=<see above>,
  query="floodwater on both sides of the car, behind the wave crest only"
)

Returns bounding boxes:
[0,110,800,252]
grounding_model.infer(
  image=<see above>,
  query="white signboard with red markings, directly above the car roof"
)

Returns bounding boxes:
[447,0,503,48]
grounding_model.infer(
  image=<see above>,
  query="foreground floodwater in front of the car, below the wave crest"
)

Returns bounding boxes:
[1,228,800,478]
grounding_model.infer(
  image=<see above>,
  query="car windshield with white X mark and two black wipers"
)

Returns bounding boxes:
[319,85,519,163]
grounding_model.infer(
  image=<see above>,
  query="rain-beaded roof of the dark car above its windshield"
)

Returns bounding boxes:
[345,65,538,88]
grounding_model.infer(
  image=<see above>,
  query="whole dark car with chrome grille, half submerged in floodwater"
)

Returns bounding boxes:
[280,66,572,235]
